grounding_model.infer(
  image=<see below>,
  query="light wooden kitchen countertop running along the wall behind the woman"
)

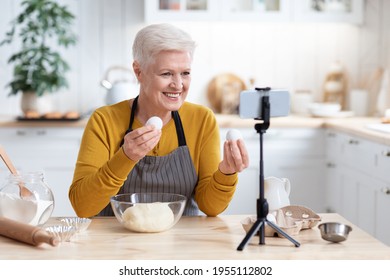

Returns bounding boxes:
[0,114,390,145]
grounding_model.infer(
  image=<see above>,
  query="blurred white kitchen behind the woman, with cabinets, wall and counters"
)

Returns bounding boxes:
[0,0,390,245]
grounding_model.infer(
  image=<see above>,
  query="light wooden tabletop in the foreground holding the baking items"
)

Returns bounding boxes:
[0,214,390,260]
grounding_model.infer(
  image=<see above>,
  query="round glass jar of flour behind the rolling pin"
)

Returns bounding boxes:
[0,172,54,226]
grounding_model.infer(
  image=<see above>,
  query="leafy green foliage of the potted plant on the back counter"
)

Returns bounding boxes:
[0,0,77,115]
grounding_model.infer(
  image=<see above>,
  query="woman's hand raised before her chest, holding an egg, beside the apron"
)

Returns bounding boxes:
[122,125,161,161]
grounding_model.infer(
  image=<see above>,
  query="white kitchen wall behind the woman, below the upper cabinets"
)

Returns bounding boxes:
[0,0,390,115]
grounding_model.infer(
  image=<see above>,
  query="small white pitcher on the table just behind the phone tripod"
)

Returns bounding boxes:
[264,176,291,212]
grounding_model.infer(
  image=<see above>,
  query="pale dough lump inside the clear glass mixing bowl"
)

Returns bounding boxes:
[122,202,174,232]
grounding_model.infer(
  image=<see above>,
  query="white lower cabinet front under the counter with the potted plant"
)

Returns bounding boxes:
[0,127,83,216]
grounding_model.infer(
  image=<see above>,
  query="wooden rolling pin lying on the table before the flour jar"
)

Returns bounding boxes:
[0,217,60,246]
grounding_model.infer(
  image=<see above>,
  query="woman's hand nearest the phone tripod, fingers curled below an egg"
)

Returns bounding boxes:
[219,139,249,174]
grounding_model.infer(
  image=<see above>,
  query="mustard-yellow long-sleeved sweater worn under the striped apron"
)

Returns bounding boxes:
[69,100,238,217]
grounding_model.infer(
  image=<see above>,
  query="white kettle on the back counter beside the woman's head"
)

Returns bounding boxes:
[100,66,139,105]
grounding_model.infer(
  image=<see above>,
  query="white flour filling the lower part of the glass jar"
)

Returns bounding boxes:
[0,192,53,226]
